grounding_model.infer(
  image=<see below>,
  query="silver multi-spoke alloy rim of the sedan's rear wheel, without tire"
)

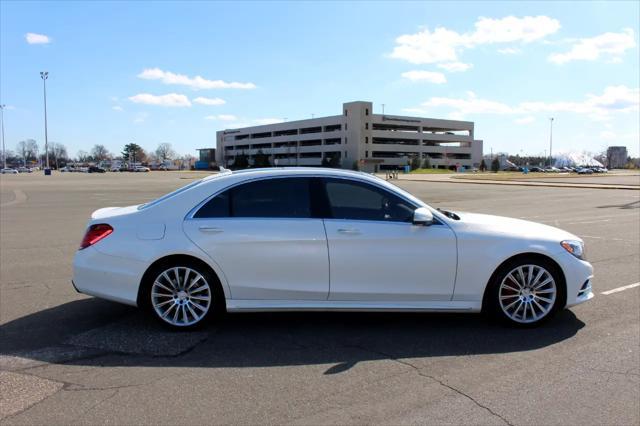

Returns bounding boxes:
[151,266,211,327]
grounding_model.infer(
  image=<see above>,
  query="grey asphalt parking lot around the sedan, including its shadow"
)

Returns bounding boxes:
[0,172,640,425]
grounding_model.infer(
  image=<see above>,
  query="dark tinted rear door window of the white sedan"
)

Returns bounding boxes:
[193,178,311,218]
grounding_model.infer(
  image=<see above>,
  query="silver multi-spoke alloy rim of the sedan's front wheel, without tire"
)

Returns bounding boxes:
[498,265,558,324]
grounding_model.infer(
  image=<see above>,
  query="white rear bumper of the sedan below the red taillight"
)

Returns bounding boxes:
[71,247,147,306]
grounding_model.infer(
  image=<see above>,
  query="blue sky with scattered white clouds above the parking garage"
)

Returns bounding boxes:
[0,1,640,156]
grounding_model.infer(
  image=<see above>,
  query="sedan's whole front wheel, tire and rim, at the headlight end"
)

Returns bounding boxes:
[485,259,564,326]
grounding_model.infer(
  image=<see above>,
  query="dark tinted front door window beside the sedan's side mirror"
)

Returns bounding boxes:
[325,179,415,222]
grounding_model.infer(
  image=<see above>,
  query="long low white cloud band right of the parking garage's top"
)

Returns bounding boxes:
[405,86,640,120]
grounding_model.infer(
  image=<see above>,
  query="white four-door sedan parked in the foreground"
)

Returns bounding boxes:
[73,168,593,328]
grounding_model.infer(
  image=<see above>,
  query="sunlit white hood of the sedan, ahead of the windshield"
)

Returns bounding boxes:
[453,212,582,242]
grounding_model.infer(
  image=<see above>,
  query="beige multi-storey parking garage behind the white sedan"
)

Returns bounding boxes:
[217,101,482,172]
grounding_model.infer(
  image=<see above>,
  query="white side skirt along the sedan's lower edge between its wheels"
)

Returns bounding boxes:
[227,299,482,312]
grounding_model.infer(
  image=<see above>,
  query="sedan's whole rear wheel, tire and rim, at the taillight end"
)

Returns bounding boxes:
[147,262,220,329]
